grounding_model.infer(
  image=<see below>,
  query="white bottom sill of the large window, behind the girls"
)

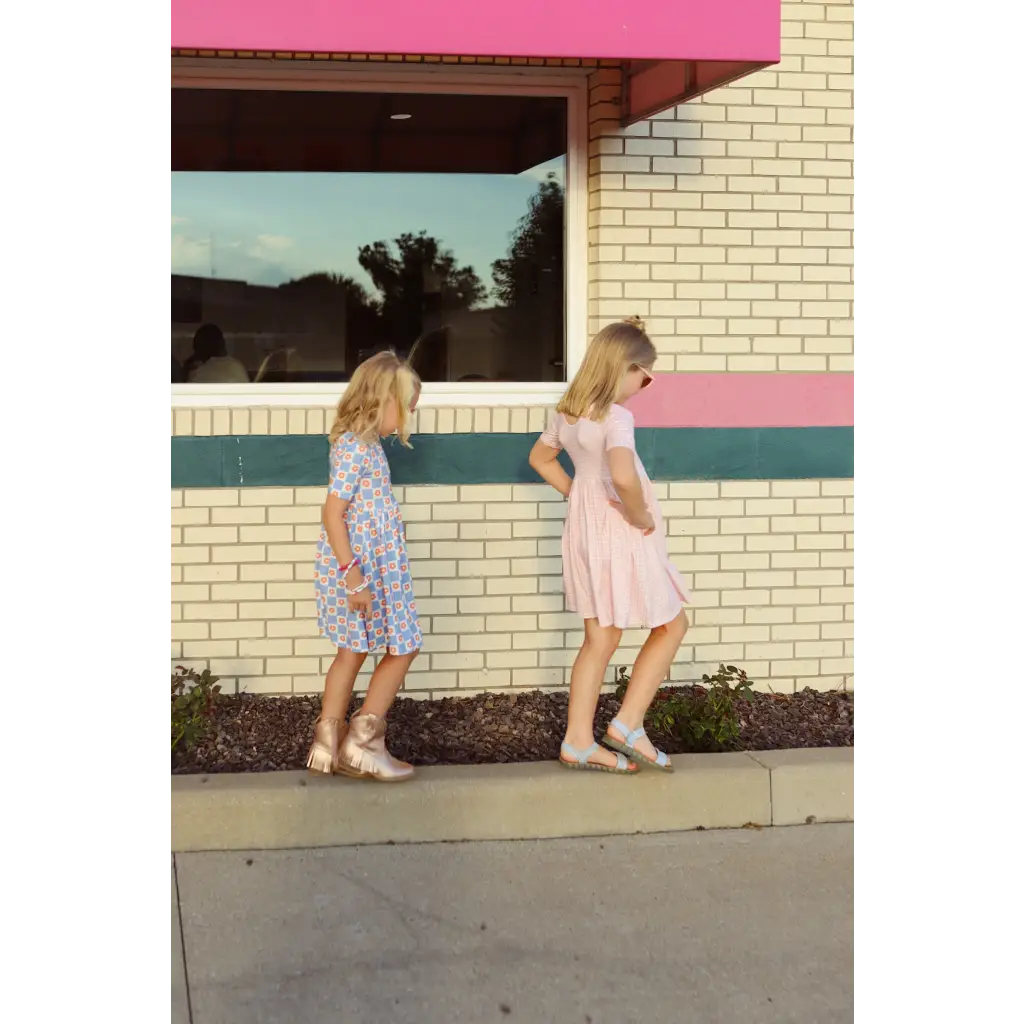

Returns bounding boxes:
[167,381,568,409]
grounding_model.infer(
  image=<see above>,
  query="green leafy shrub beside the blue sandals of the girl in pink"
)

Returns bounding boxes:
[615,665,754,753]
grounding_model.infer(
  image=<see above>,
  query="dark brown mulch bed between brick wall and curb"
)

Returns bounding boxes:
[171,687,854,775]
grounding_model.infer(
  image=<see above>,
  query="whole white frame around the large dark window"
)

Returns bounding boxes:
[167,57,589,409]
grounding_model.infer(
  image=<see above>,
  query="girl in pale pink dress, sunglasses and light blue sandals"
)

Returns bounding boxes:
[529,317,690,775]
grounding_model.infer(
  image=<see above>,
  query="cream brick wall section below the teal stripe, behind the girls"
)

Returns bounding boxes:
[171,480,854,696]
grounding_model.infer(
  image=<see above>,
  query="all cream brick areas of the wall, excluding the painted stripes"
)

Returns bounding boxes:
[170,0,855,696]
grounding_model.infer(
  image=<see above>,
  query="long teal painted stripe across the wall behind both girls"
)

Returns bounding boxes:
[169,427,856,487]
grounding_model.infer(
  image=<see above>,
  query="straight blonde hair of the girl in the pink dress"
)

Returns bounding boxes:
[557,316,657,422]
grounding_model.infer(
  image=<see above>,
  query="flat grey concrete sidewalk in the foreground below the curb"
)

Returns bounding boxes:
[169,824,855,1024]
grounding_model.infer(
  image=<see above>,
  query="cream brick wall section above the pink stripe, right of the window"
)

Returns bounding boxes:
[589,0,855,373]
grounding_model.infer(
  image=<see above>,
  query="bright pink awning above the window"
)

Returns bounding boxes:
[169,0,781,122]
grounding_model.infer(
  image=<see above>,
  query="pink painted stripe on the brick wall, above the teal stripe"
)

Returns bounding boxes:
[630,374,856,427]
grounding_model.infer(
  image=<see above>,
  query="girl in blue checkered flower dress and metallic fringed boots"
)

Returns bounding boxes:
[306,352,423,782]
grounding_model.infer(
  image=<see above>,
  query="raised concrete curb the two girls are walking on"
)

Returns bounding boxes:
[169,746,855,853]
